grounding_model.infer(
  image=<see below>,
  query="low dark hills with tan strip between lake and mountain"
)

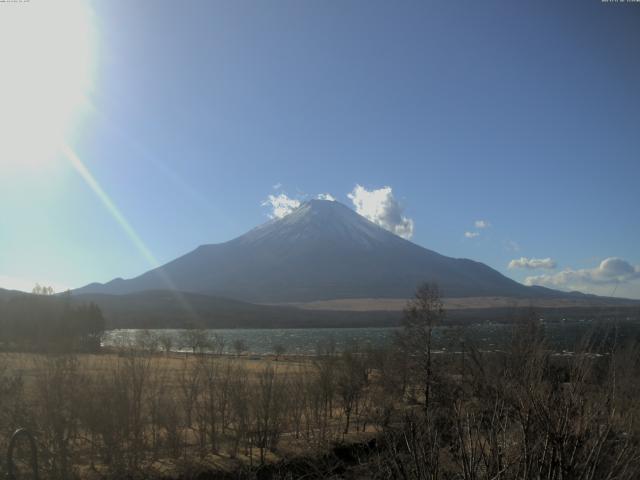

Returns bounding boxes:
[0,289,640,329]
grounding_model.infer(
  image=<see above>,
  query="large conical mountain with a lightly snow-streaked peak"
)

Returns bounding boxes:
[76,200,564,303]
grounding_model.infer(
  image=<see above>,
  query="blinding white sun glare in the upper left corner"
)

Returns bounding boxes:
[0,0,94,169]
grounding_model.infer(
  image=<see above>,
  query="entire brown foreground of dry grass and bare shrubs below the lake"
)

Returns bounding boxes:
[0,326,640,480]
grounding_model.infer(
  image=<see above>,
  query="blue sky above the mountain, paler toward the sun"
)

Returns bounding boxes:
[0,0,640,298]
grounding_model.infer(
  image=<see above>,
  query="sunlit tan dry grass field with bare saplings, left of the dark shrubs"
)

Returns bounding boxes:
[0,350,384,479]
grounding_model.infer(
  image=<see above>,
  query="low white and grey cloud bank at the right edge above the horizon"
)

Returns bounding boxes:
[525,257,640,297]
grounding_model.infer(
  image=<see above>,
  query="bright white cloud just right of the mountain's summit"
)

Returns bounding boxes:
[347,185,413,238]
